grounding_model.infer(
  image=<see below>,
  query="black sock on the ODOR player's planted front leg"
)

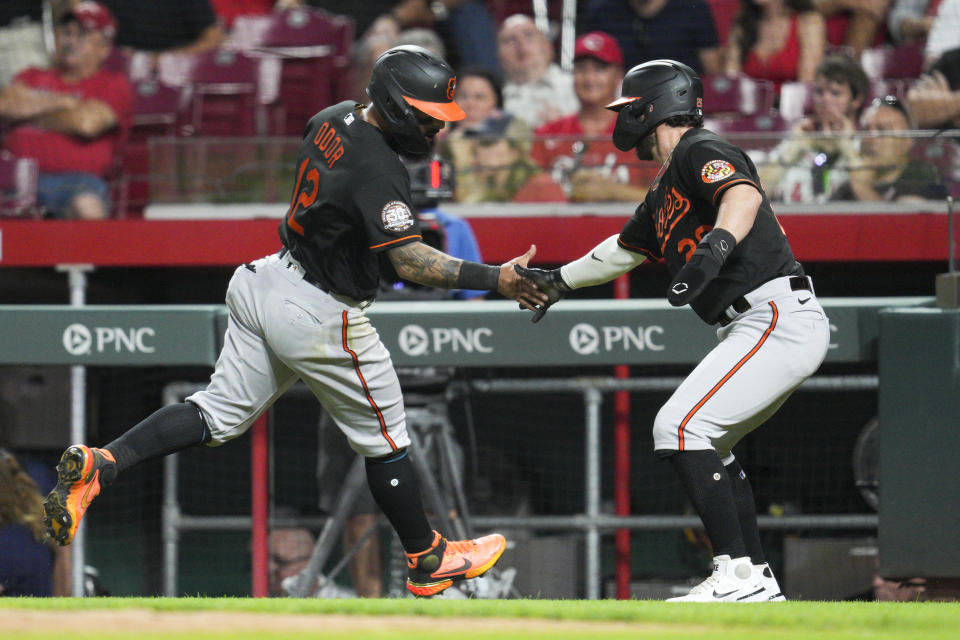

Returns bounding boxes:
[366,451,433,553]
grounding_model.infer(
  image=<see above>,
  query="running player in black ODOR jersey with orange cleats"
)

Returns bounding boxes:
[44,46,547,596]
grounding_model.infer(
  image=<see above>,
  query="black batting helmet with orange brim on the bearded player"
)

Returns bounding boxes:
[367,45,464,156]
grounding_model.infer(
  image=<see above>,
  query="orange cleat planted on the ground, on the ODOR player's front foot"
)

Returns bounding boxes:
[407,531,507,596]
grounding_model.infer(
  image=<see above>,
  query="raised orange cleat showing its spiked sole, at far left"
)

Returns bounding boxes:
[43,444,117,546]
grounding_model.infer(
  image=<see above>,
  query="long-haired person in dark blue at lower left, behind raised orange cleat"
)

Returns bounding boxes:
[0,448,70,597]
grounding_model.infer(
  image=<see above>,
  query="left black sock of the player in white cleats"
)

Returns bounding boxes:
[670,451,747,558]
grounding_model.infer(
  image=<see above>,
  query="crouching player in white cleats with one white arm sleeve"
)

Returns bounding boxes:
[517,60,829,602]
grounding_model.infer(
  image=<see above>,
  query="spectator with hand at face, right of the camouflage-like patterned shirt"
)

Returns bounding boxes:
[830,96,947,202]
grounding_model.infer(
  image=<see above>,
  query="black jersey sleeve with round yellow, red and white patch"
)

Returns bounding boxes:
[680,137,763,207]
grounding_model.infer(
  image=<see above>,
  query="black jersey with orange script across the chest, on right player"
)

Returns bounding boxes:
[619,128,803,324]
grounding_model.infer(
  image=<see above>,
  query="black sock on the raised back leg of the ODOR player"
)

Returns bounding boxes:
[103,402,210,483]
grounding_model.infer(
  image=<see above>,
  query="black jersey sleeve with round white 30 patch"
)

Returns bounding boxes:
[353,175,422,253]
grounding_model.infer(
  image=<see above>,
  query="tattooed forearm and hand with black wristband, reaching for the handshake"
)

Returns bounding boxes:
[387,242,547,311]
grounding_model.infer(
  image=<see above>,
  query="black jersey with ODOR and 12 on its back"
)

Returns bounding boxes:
[280,101,421,300]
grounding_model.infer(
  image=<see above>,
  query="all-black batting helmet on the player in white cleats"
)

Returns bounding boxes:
[607,60,703,151]
